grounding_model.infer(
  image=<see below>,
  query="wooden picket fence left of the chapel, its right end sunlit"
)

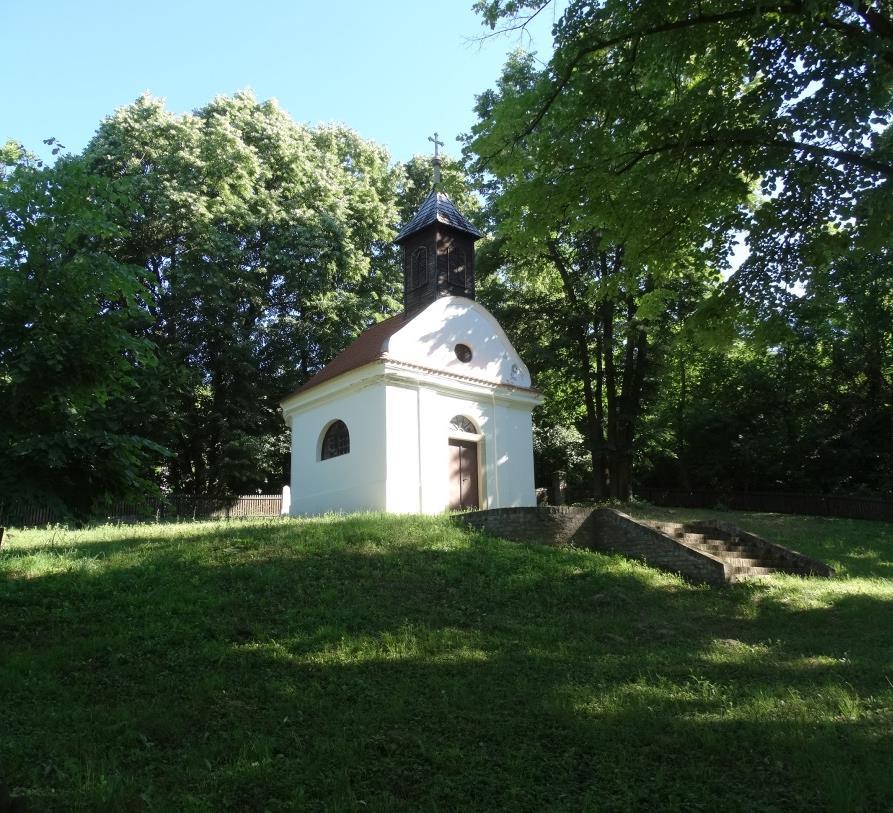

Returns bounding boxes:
[0,494,282,528]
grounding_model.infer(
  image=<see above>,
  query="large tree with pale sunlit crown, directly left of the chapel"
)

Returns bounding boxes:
[83,93,399,493]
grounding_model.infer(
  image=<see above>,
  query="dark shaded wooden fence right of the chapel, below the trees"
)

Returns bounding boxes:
[636,488,893,522]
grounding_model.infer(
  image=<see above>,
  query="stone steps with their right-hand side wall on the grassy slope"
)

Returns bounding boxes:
[640,520,833,582]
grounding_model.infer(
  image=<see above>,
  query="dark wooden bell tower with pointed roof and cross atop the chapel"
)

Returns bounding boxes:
[394,133,483,317]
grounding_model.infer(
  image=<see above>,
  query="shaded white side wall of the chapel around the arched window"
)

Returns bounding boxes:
[291,383,385,516]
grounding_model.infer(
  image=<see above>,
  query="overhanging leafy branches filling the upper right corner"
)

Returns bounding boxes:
[477,0,893,301]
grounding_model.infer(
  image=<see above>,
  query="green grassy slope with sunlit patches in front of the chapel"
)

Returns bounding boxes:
[0,508,893,811]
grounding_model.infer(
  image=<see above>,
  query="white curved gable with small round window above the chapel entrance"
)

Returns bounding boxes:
[384,296,530,387]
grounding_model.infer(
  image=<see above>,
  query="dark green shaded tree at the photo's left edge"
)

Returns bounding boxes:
[0,145,164,513]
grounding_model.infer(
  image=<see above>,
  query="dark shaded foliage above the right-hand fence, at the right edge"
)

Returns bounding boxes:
[640,243,893,494]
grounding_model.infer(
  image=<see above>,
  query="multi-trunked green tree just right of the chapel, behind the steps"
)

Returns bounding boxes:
[468,55,741,499]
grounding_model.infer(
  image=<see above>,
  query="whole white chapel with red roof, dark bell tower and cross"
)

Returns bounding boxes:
[281,143,542,516]
